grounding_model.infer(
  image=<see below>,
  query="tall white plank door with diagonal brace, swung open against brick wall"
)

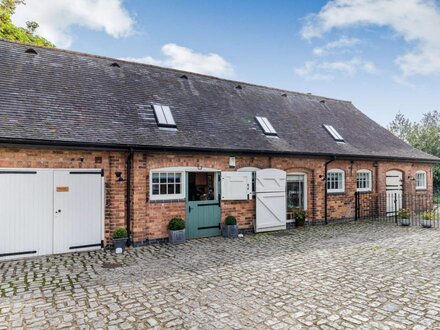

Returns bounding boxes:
[255,169,286,232]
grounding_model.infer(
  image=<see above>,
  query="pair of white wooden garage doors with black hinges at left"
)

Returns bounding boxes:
[0,168,104,260]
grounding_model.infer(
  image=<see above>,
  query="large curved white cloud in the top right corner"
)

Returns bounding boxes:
[301,0,440,77]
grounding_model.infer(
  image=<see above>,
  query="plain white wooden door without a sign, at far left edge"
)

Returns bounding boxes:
[0,169,53,261]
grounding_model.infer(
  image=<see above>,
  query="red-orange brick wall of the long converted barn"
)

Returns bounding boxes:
[0,148,432,242]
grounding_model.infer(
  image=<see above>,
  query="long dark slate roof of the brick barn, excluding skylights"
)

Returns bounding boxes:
[0,40,438,161]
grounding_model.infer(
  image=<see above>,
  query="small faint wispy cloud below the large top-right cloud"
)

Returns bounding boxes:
[295,57,378,80]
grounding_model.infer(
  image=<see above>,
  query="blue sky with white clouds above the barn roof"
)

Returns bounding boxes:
[13,0,440,126]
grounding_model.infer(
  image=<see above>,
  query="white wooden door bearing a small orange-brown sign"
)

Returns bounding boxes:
[53,170,103,253]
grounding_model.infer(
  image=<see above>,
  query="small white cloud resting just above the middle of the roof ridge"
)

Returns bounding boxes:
[124,43,234,77]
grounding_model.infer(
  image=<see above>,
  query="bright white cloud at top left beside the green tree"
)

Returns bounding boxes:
[12,0,134,48]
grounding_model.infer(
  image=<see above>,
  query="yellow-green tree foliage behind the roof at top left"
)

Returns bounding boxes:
[0,0,55,47]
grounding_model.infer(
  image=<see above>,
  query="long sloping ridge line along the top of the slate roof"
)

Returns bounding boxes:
[0,38,352,103]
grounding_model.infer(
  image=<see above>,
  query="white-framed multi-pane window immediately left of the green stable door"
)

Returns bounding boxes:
[150,172,184,200]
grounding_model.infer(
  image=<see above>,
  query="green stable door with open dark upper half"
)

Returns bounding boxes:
[186,172,221,238]
